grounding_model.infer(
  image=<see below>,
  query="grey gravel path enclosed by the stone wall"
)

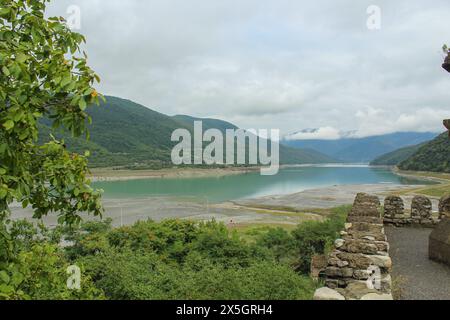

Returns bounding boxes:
[386,227,450,300]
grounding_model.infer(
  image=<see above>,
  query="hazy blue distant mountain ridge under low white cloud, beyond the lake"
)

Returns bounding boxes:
[282,132,438,163]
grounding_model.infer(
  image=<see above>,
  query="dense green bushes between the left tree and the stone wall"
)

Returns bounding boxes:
[63,220,317,300]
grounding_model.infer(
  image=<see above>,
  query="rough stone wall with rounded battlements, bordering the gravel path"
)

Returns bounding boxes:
[314,193,450,300]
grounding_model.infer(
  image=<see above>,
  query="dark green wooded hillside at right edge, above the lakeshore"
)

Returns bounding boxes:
[399,132,450,172]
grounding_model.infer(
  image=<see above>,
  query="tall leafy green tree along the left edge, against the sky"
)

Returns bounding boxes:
[0,0,101,230]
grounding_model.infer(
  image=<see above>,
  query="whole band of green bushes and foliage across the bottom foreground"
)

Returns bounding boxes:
[0,207,349,300]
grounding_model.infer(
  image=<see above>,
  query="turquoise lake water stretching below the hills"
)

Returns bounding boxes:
[94,166,427,202]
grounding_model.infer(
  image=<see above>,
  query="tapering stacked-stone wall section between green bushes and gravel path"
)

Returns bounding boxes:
[314,193,392,300]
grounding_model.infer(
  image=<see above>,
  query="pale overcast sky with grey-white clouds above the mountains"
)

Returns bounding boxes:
[48,0,450,138]
